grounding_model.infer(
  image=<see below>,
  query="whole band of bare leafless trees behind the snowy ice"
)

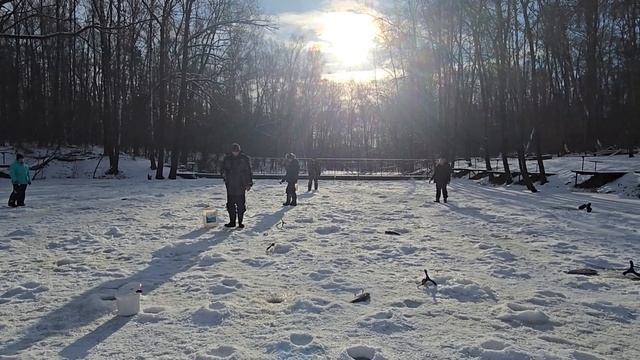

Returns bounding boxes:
[0,0,640,188]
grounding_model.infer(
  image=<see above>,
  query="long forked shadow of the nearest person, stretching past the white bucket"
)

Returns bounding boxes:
[0,226,230,358]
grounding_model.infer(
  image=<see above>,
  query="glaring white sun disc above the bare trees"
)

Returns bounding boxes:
[320,12,378,67]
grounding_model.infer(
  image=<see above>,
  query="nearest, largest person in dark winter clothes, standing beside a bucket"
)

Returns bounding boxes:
[222,143,253,228]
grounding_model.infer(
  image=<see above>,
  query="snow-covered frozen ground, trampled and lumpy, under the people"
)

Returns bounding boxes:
[0,155,640,360]
